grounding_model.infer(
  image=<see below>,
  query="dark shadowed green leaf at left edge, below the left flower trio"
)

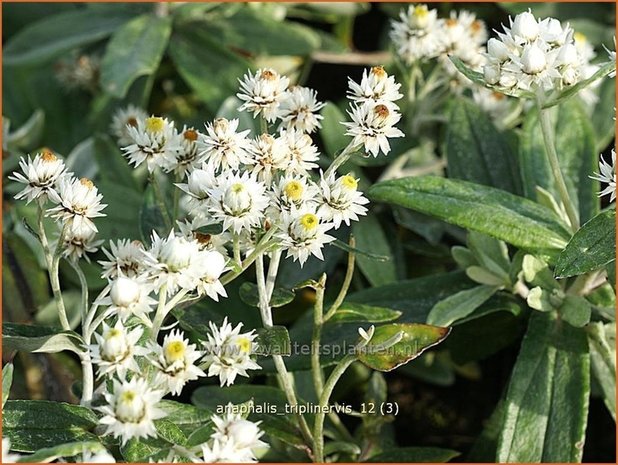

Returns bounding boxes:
[2,232,50,321]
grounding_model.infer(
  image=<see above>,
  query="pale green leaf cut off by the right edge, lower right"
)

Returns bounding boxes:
[588,322,616,421]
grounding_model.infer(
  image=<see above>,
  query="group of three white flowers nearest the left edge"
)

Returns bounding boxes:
[9,150,106,261]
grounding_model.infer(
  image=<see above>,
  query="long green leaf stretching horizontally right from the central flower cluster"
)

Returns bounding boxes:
[368,176,569,250]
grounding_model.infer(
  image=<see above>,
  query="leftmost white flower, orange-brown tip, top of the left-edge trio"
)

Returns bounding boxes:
[9,150,66,203]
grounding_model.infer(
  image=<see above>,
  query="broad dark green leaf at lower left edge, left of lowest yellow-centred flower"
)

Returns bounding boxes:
[2,400,99,452]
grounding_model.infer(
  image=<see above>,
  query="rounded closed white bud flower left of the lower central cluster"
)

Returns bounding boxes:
[98,276,157,322]
